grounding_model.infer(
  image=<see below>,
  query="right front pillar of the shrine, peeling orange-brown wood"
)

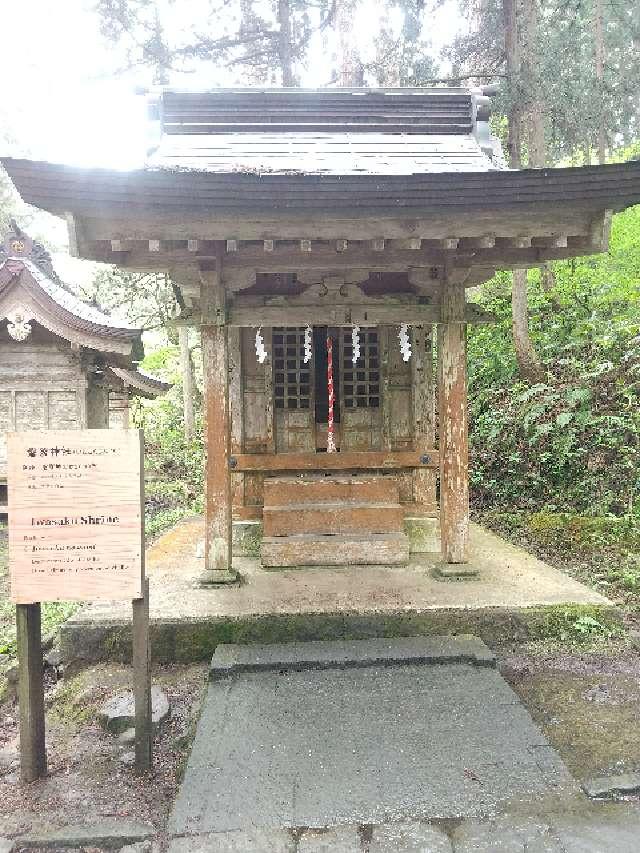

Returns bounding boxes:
[438,280,469,563]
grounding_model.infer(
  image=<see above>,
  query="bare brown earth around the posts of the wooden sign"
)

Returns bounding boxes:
[0,665,206,839]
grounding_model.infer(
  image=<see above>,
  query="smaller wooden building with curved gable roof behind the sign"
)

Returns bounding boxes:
[0,225,169,513]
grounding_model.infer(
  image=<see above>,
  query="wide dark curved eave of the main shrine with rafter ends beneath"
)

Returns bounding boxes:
[2,159,640,272]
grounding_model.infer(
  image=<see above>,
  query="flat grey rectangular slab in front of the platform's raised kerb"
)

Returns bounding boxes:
[169,642,577,835]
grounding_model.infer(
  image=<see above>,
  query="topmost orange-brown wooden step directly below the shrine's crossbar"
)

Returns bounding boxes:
[264,476,400,506]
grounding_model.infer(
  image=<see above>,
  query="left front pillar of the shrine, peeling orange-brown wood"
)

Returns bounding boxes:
[200,257,234,583]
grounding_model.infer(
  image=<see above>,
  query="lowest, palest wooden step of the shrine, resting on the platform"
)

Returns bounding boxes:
[260,533,409,568]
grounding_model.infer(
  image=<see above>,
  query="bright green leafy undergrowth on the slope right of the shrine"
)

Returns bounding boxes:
[469,207,640,515]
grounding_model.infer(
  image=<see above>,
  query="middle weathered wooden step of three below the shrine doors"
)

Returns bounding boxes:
[262,503,404,536]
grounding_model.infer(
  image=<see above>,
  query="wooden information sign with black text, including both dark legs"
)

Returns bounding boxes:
[7,429,151,782]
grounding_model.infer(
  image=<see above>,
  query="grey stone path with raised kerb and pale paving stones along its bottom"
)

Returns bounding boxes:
[169,638,640,853]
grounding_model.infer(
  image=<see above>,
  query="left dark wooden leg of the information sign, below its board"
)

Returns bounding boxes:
[16,604,47,782]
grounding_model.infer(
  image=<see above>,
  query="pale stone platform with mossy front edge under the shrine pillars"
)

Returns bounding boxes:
[61,518,618,662]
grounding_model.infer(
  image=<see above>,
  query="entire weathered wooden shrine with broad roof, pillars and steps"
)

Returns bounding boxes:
[2,88,640,581]
